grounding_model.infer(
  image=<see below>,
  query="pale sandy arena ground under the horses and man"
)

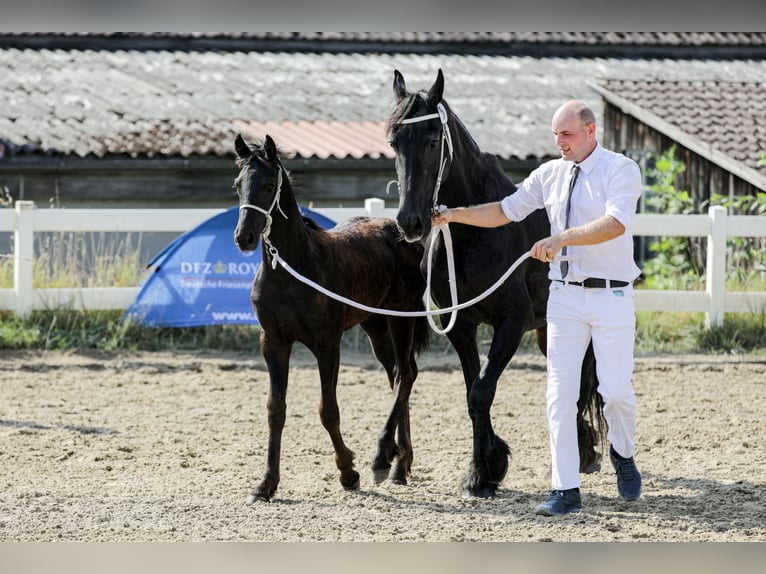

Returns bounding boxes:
[0,348,766,542]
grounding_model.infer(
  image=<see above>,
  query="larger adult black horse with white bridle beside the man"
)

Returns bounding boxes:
[387,70,605,498]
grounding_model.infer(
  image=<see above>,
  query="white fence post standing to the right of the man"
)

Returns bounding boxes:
[705,205,726,329]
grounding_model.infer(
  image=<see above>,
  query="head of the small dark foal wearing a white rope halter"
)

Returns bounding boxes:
[234,134,283,251]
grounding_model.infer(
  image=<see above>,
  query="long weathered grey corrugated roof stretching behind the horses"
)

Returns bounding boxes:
[0,48,766,164]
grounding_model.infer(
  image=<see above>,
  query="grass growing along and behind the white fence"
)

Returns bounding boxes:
[0,220,766,353]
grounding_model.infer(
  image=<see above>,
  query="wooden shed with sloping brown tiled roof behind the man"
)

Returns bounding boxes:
[594,80,766,211]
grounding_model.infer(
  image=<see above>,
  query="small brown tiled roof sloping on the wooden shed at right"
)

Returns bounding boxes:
[603,80,766,175]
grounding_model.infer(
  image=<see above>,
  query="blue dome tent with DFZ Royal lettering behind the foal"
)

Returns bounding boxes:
[123,207,335,327]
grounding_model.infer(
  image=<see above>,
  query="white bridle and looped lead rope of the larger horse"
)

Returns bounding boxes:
[399,102,458,335]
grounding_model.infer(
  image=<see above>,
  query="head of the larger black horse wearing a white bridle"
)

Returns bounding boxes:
[386,70,452,241]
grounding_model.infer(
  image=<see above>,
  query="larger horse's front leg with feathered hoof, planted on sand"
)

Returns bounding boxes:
[461,316,524,498]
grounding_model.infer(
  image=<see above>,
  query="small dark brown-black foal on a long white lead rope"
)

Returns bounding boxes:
[234,134,430,502]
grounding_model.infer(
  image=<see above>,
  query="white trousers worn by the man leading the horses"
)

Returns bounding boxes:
[546,281,636,490]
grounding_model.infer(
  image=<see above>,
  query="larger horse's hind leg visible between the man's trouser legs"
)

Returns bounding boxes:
[577,342,606,474]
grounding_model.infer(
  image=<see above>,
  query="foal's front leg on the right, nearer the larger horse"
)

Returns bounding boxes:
[314,339,359,490]
